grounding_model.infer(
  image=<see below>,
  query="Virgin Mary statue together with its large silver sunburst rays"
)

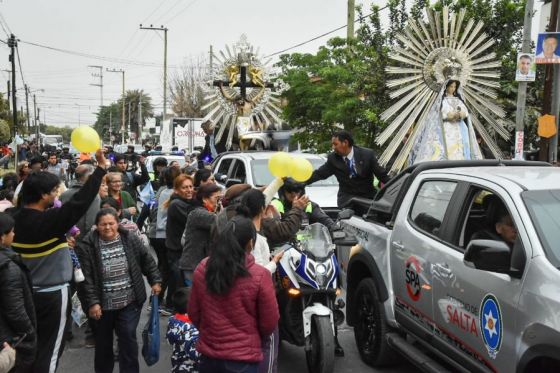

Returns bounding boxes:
[376,6,512,173]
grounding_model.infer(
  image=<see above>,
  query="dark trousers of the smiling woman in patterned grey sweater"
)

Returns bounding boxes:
[95,303,141,373]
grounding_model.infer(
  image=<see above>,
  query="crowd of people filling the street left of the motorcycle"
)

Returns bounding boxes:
[0,137,328,372]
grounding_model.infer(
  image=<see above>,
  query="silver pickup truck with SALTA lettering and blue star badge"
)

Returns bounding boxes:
[338,160,560,372]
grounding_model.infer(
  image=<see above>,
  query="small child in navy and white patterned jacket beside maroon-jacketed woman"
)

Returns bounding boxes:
[167,288,200,373]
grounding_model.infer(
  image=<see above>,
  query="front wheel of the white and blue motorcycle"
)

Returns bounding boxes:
[305,315,334,373]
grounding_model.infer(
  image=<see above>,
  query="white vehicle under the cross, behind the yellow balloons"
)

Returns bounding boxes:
[212,151,339,217]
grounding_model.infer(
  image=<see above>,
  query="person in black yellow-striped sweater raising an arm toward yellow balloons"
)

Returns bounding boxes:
[12,149,106,373]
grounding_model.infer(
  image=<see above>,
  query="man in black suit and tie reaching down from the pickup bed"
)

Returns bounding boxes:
[306,131,389,207]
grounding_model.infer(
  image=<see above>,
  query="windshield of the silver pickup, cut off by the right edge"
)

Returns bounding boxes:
[521,189,560,268]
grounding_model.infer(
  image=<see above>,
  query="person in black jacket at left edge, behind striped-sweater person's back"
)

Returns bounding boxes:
[0,213,37,372]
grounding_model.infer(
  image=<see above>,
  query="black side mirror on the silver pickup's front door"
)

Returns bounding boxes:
[463,240,517,277]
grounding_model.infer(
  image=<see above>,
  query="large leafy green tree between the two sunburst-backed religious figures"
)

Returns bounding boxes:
[278,6,388,152]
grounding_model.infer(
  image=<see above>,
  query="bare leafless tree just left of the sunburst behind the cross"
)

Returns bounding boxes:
[169,58,208,118]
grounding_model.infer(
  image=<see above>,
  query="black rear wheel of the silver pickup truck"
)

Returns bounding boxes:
[354,278,395,367]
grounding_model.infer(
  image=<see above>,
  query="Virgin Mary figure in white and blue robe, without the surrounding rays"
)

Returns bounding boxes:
[409,79,483,164]
